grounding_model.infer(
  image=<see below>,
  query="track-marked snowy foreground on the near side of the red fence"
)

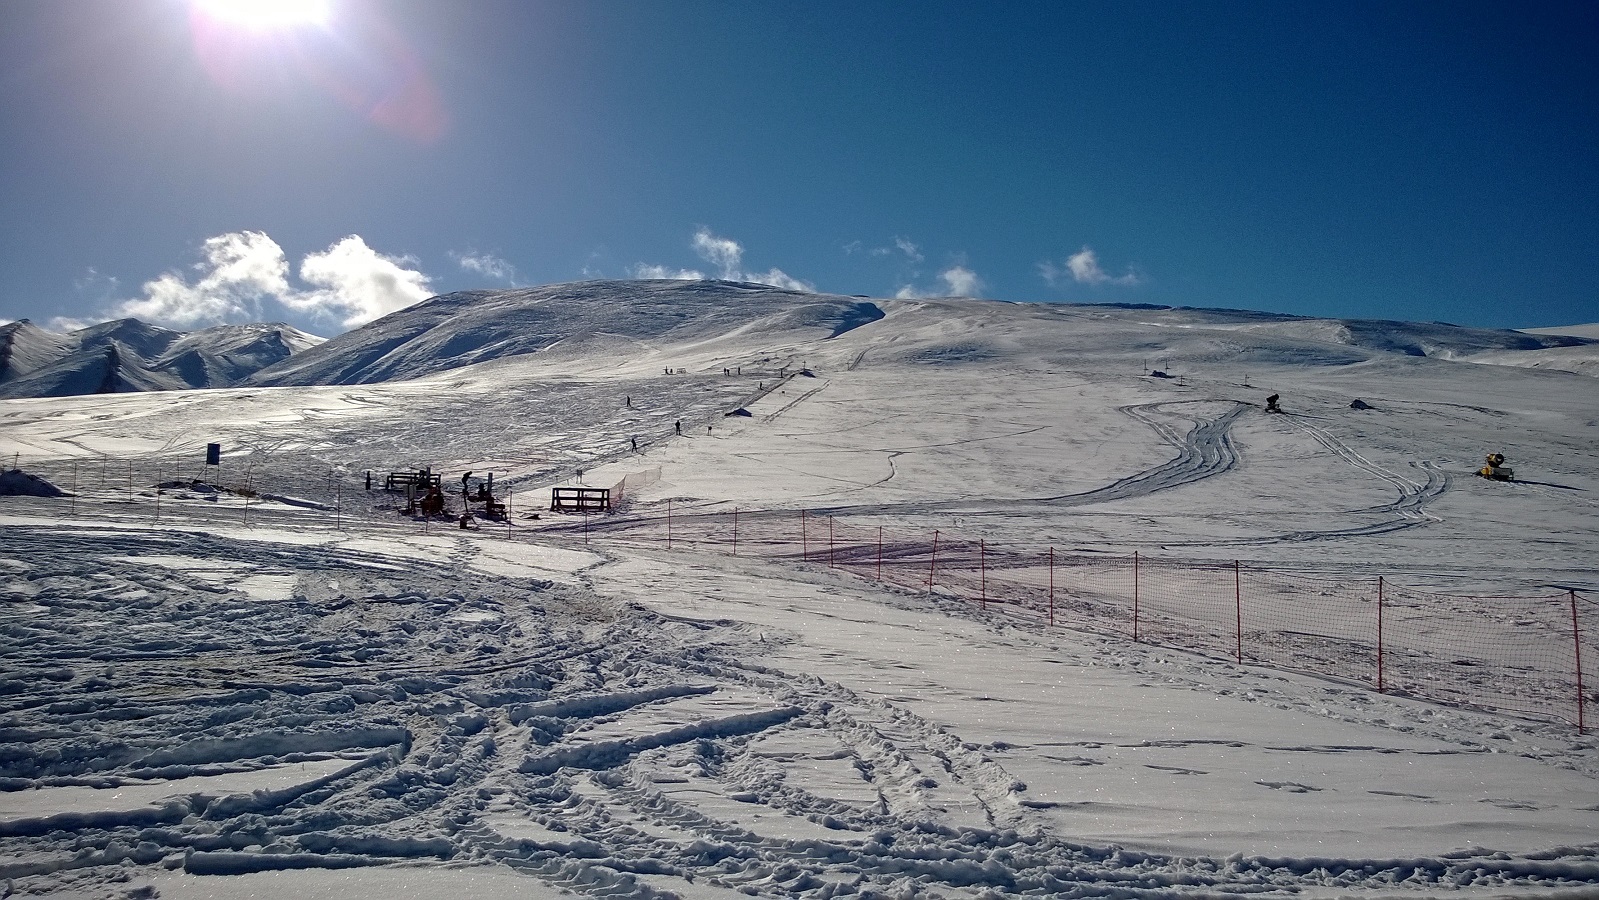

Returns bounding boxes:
[0,523,1599,897]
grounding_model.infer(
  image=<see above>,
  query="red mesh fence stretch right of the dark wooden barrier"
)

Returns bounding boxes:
[591,510,1599,729]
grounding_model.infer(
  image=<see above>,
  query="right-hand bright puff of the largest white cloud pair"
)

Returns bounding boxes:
[283,235,432,328]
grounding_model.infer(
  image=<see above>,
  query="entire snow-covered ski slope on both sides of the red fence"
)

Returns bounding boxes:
[0,283,1599,898]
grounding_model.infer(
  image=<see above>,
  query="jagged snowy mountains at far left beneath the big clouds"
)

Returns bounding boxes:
[0,318,321,400]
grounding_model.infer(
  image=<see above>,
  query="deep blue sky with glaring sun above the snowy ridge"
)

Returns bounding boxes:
[0,0,1599,334]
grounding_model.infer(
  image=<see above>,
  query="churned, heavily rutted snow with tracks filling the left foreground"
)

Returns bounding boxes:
[0,526,1599,897]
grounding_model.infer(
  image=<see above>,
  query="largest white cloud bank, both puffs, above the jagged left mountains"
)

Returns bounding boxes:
[99,232,430,328]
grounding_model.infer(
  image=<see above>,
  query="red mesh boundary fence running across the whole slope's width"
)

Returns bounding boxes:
[0,457,1599,731]
